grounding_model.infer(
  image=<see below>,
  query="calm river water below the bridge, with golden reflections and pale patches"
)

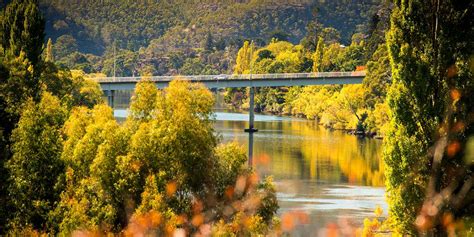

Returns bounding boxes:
[215,112,387,236]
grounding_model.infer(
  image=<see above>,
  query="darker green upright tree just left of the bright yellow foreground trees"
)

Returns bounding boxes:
[7,92,66,230]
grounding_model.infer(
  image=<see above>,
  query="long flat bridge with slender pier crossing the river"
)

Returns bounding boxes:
[93,71,365,164]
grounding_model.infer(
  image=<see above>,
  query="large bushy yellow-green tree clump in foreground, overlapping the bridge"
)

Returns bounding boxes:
[51,80,277,235]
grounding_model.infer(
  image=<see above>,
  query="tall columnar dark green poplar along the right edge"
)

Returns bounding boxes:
[384,0,474,234]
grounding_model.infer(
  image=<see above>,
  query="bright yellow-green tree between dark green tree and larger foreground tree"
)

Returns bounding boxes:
[51,104,124,234]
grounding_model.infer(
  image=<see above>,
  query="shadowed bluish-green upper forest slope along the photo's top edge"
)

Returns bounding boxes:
[40,0,380,51]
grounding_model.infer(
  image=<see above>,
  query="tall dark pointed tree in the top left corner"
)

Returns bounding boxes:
[0,0,44,126]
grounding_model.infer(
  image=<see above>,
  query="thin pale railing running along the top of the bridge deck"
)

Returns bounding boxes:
[92,71,366,83]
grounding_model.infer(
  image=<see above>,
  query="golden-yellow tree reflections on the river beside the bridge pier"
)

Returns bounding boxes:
[215,113,383,187]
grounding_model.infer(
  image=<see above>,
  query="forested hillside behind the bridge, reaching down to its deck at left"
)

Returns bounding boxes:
[35,0,380,75]
